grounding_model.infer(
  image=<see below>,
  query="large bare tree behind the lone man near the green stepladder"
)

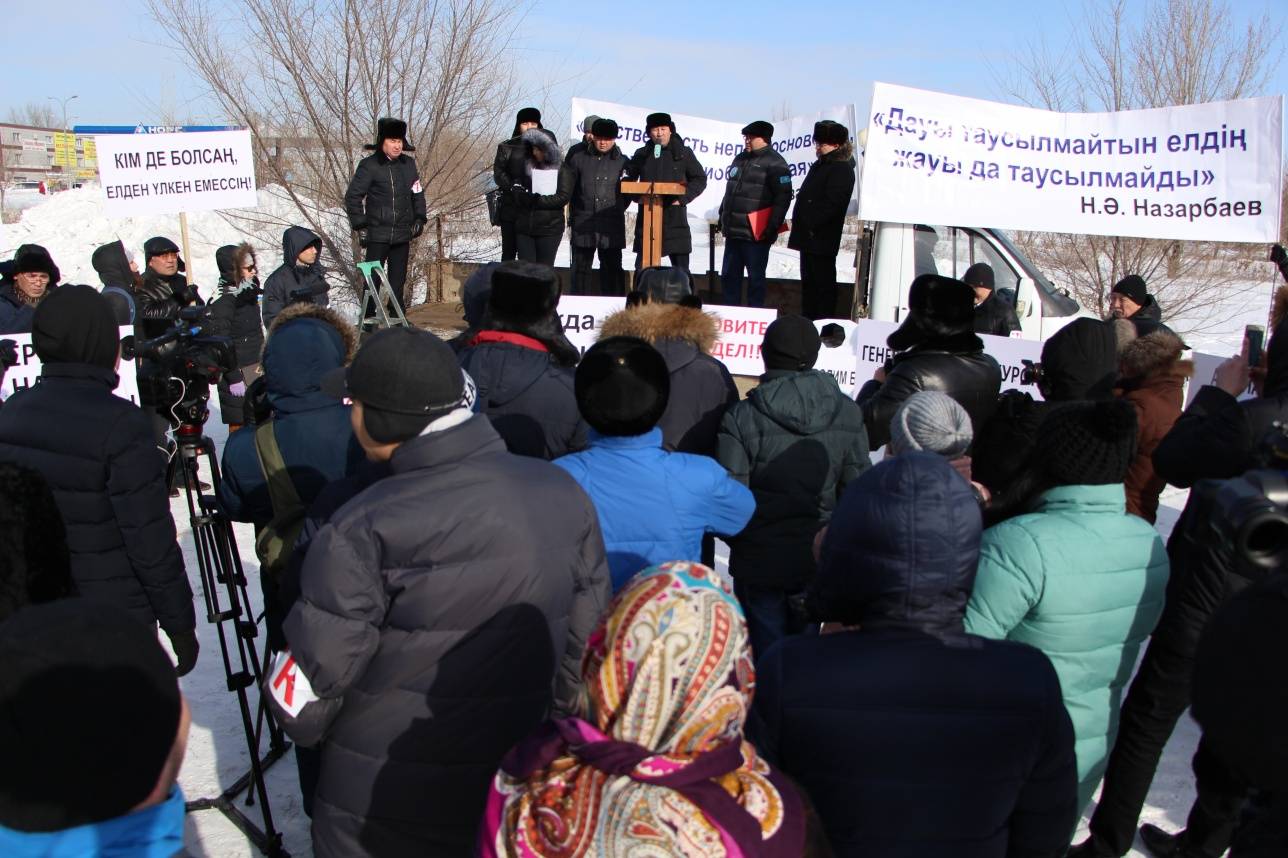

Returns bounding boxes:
[148,0,519,302]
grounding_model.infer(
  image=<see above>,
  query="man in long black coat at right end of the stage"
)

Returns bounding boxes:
[787,120,854,319]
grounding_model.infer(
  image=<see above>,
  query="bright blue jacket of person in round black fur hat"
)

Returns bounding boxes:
[554,429,756,593]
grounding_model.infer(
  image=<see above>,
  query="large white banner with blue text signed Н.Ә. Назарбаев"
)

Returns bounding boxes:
[862,82,1283,242]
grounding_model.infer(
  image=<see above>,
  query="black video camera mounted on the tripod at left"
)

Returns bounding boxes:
[121,307,238,426]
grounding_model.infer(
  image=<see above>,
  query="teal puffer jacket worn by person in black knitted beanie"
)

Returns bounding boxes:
[966,484,1168,810]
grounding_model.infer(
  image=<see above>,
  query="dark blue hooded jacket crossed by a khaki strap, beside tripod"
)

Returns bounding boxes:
[219,304,363,524]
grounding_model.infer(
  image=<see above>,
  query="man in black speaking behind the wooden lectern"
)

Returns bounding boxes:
[626,113,707,271]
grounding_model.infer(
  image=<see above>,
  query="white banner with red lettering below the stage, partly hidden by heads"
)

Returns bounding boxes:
[559,295,778,375]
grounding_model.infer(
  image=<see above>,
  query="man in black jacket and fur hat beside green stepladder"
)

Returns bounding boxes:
[344,117,429,307]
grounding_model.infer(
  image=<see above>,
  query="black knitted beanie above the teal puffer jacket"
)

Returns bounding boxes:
[1033,399,1136,486]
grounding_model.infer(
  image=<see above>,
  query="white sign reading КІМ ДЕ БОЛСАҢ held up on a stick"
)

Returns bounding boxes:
[94,130,259,218]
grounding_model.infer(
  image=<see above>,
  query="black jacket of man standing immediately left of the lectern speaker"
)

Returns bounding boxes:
[559,146,630,250]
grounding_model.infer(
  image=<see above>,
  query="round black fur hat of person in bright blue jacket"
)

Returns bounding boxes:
[573,336,671,437]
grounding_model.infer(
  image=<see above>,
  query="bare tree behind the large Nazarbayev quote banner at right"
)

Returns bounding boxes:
[999,0,1282,331]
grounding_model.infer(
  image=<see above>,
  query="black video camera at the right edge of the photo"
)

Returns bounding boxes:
[1194,421,1288,580]
